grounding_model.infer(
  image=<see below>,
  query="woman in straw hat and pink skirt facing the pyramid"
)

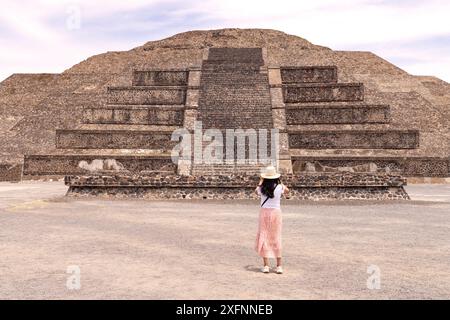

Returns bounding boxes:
[255,166,289,274]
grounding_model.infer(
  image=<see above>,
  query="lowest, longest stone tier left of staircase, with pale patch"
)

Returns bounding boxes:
[24,154,177,176]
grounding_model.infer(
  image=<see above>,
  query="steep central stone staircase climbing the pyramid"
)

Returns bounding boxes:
[192,48,273,175]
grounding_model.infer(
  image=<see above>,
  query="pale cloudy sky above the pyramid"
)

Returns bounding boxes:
[0,0,450,82]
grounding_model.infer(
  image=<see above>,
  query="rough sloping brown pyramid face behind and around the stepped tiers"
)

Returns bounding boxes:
[0,29,450,179]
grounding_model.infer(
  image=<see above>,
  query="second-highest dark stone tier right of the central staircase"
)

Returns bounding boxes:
[283,83,364,103]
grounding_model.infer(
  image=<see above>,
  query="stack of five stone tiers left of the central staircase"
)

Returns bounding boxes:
[24,69,189,177]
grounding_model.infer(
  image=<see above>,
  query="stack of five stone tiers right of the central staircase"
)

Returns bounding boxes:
[280,66,449,177]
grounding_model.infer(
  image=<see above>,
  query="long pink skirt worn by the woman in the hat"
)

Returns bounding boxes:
[255,208,282,258]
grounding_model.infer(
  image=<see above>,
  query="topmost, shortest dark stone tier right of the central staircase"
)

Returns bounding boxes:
[280,66,338,84]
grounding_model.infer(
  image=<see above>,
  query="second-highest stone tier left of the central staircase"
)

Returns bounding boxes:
[107,86,187,105]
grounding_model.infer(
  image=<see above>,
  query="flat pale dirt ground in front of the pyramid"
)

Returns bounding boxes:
[0,182,450,299]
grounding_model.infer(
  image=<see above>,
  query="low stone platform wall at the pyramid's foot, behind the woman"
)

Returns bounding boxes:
[65,173,409,200]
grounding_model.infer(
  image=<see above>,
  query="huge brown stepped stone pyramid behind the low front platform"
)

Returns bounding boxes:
[0,29,450,198]
